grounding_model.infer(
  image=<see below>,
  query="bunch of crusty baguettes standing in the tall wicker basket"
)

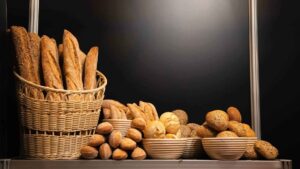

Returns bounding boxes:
[10,26,98,101]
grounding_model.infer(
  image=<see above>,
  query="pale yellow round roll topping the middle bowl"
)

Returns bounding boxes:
[159,112,180,134]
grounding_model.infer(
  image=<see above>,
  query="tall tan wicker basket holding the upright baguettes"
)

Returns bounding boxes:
[14,72,107,159]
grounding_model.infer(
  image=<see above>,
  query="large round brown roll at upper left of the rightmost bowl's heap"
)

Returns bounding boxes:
[205,110,229,131]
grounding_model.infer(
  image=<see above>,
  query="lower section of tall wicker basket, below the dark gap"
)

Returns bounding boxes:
[23,130,95,160]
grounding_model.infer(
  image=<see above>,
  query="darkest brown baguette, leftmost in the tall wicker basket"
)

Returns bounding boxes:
[11,26,43,99]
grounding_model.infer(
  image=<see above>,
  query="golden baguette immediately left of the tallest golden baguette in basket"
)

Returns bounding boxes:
[41,35,64,101]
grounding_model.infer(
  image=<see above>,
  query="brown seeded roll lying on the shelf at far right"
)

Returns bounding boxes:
[254,140,278,160]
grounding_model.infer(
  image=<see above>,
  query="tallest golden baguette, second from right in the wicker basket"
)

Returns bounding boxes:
[63,30,83,101]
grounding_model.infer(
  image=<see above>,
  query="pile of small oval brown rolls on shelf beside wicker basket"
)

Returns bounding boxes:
[80,122,147,160]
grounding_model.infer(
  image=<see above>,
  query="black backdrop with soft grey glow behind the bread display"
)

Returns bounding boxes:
[0,0,300,168]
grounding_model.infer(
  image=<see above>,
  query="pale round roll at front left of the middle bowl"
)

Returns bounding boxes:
[143,121,166,138]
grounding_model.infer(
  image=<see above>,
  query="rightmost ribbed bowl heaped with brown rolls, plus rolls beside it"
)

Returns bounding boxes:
[197,106,278,160]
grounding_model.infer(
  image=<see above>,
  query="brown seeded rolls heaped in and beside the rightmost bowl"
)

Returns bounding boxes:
[196,107,278,159]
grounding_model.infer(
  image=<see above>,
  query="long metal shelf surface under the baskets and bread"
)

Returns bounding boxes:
[0,159,292,169]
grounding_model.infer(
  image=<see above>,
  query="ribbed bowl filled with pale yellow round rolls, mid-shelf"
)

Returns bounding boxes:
[143,112,186,159]
